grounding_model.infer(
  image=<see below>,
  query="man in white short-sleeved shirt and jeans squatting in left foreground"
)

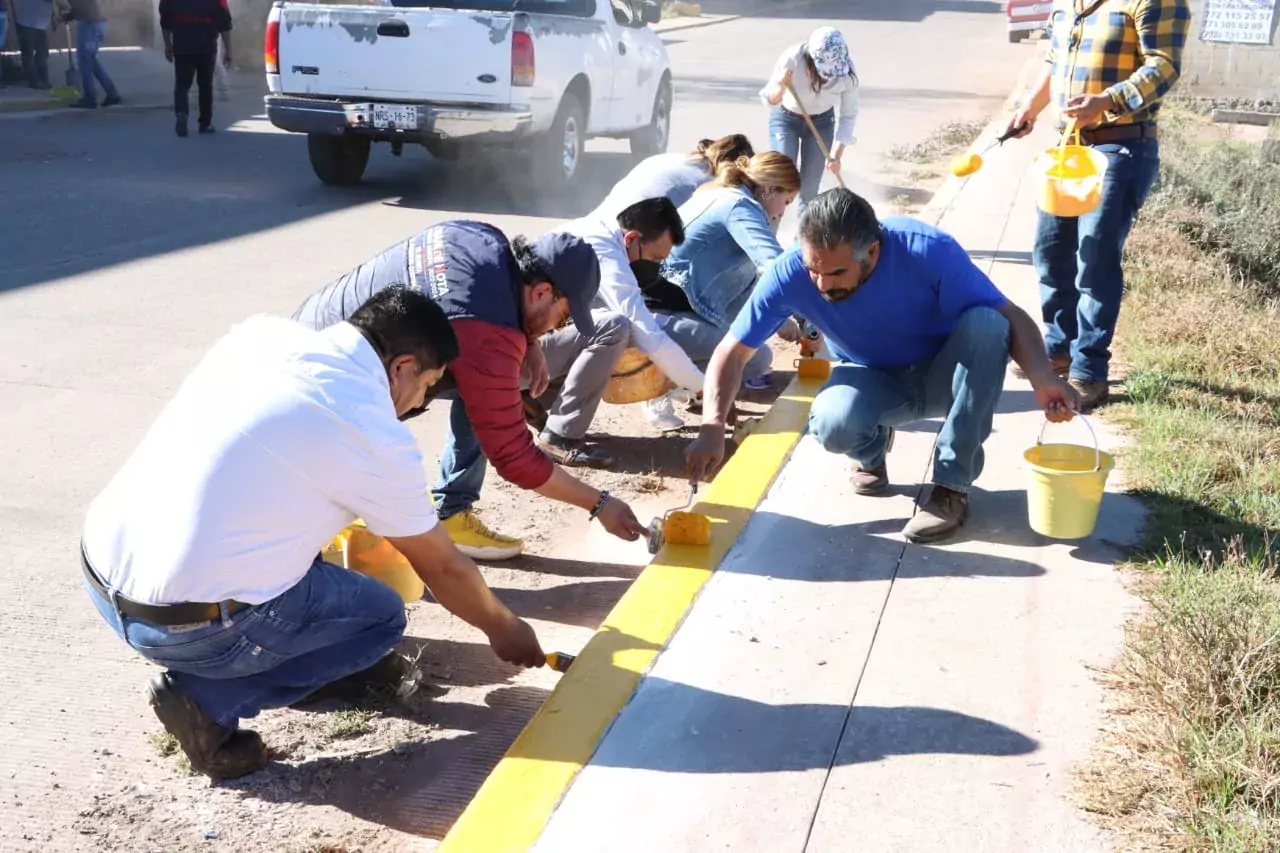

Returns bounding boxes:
[82,287,545,779]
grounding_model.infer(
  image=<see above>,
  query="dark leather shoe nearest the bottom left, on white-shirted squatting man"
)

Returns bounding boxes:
[147,672,268,779]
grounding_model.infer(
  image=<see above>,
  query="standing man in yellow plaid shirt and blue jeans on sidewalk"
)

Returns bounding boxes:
[1009,0,1190,412]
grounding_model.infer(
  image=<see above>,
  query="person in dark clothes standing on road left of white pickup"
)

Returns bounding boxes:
[160,0,232,136]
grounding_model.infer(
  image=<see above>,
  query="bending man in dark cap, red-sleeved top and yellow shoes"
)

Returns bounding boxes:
[293,220,646,560]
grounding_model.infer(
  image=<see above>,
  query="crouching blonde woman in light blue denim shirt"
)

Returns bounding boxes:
[644,151,800,429]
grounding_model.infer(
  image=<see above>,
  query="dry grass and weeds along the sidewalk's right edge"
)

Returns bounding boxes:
[1082,111,1280,852]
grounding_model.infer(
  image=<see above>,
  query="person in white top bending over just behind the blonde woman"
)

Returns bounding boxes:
[591,133,755,222]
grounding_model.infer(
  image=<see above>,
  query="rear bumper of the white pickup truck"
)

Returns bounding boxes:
[262,95,534,143]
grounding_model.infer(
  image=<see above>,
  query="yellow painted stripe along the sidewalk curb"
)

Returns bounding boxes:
[436,378,823,853]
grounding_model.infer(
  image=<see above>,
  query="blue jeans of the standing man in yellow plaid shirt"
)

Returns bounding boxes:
[1033,140,1160,382]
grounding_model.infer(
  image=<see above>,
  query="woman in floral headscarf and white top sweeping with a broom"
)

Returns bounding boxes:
[760,27,858,213]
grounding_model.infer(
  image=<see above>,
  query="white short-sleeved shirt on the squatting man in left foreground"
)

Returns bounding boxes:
[83,316,436,605]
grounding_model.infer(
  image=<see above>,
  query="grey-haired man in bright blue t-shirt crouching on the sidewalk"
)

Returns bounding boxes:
[686,188,1079,542]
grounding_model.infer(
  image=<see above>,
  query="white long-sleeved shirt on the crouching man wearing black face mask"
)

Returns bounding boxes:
[561,216,705,392]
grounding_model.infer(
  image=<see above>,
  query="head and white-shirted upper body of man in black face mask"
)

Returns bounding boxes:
[563,196,704,429]
